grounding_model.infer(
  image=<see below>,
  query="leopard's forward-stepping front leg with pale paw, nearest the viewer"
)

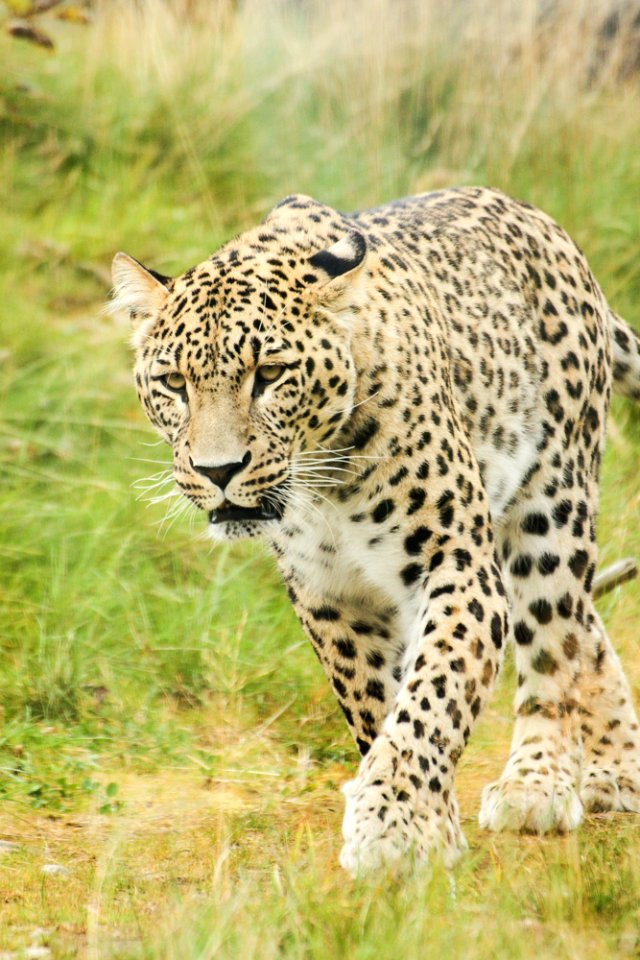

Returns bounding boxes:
[340,548,508,873]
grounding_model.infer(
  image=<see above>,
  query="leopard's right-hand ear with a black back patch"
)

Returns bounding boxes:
[308,230,367,310]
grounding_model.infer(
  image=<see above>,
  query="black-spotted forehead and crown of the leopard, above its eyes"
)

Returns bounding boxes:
[141,215,362,380]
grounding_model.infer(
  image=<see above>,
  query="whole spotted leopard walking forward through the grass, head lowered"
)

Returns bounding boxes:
[113,188,640,872]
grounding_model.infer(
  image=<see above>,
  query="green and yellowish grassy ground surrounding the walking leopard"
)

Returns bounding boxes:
[0,0,640,960]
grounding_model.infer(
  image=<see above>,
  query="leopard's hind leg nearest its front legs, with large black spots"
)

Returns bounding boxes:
[480,476,598,833]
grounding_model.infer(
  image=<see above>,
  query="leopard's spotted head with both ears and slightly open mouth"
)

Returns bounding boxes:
[115,222,366,539]
